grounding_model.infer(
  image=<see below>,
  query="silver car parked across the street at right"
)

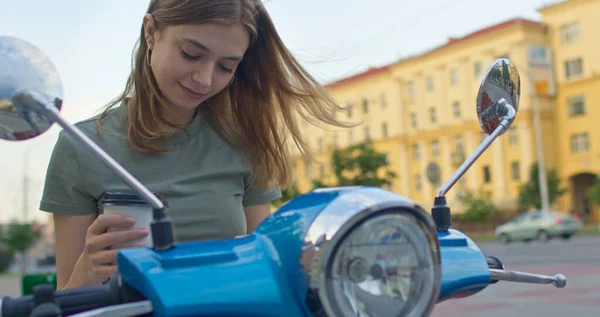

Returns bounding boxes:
[495,210,582,244]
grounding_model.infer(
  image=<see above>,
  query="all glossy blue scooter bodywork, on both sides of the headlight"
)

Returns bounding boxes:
[118,187,490,317]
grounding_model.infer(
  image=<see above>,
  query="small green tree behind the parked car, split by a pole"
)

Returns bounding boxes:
[519,162,567,209]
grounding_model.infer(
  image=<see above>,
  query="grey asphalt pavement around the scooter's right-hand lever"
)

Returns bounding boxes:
[431,236,600,317]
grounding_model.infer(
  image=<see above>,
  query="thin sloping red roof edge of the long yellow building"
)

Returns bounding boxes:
[326,18,543,88]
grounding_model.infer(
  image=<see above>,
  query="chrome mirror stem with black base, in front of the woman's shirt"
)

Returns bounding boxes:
[13,91,175,250]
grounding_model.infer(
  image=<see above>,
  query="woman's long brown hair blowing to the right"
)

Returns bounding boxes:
[99,0,352,187]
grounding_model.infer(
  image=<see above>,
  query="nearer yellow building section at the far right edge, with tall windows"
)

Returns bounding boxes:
[539,0,600,221]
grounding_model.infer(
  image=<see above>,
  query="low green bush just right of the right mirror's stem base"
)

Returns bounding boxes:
[456,190,494,223]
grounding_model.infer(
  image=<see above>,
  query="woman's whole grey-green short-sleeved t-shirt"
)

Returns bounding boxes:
[40,101,281,241]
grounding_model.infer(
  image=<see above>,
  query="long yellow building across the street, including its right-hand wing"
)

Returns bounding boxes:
[295,0,600,222]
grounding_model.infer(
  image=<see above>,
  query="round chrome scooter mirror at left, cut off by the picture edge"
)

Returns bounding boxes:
[0,36,63,141]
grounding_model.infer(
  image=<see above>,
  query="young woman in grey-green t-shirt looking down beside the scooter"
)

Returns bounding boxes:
[40,0,346,289]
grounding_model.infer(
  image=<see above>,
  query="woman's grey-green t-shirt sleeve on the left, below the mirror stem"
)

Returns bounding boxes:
[40,131,97,215]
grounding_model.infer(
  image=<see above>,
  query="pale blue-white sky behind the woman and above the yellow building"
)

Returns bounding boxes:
[0,0,558,222]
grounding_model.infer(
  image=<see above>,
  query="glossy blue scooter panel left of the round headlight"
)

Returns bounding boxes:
[118,186,338,317]
